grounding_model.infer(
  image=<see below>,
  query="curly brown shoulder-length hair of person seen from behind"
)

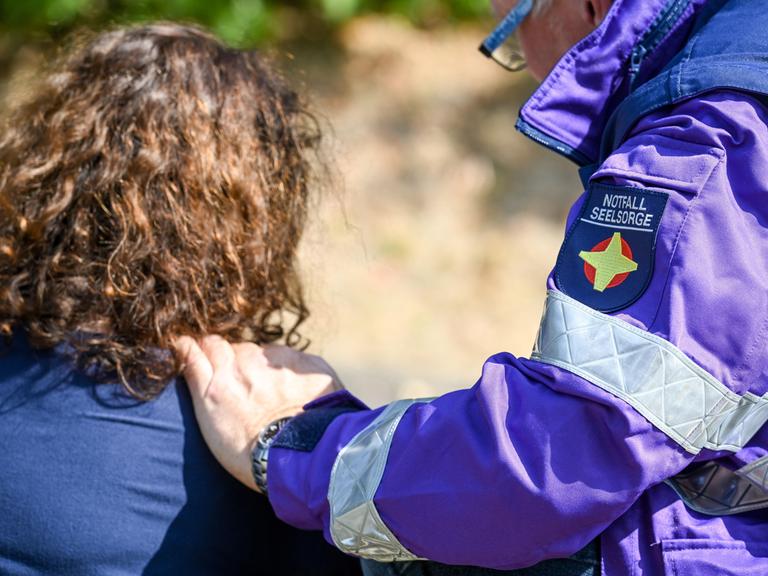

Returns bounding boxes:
[0,23,320,399]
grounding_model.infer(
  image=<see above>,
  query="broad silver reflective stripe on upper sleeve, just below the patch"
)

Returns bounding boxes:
[532,290,768,454]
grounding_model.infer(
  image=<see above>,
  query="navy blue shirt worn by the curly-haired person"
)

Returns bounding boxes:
[0,337,358,576]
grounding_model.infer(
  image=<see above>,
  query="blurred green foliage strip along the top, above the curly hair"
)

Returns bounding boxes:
[0,0,489,46]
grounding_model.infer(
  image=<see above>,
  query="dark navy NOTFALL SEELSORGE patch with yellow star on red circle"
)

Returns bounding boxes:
[555,184,668,312]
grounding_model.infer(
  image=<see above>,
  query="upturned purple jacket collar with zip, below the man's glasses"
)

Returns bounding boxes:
[517,0,707,166]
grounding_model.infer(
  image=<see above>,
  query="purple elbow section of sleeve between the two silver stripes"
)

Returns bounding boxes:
[364,357,688,569]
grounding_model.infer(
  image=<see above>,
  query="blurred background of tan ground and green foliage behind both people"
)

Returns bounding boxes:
[0,0,580,405]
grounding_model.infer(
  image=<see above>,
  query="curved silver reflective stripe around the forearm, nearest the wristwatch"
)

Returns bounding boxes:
[328,400,429,562]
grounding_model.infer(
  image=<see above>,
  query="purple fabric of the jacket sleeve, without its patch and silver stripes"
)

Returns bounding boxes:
[269,92,768,569]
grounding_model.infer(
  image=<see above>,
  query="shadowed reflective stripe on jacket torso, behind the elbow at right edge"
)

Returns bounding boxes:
[666,460,768,516]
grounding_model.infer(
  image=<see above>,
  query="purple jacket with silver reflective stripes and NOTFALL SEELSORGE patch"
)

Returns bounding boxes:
[269,0,768,576]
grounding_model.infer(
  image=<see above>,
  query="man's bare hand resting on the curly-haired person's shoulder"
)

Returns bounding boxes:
[176,336,341,490]
